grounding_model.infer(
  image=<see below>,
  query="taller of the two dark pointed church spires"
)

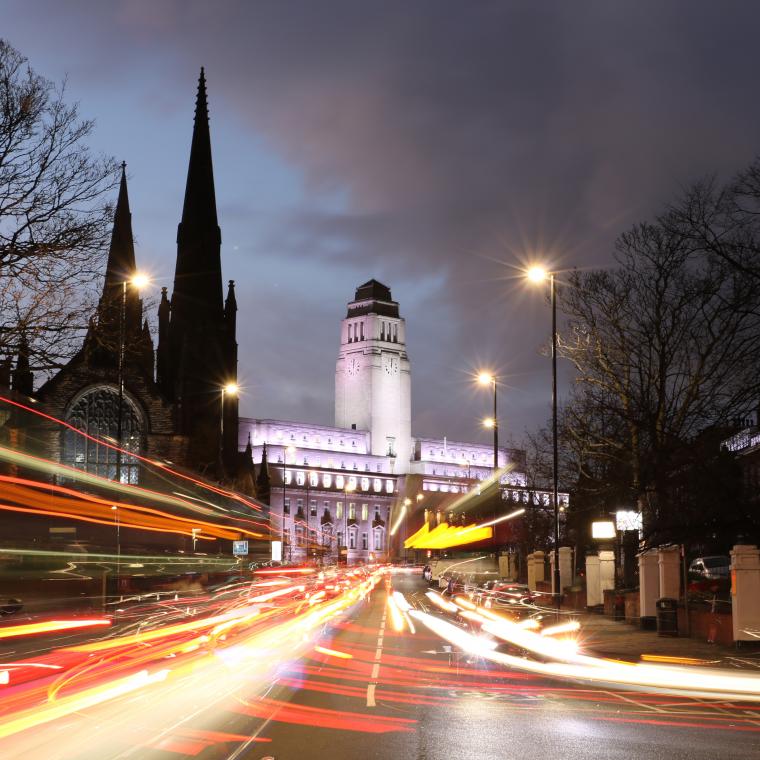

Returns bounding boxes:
[172,69,223,324]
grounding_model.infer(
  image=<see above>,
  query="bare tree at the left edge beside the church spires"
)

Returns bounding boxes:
[0,39,118,378]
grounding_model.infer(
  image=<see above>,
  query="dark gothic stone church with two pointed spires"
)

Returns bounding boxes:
[33,69,246,486]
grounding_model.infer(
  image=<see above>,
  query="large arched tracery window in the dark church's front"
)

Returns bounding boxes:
[62,386,144,483]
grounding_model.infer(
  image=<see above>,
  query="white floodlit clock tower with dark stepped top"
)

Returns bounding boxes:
[335,280,412,473]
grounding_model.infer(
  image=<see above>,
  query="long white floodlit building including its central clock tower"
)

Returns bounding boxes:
[239,280,567,564]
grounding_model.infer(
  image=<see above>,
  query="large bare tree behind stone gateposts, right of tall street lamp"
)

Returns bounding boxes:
[560,218,760,540]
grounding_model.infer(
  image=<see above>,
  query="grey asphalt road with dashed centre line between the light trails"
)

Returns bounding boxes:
[153,574,760,760]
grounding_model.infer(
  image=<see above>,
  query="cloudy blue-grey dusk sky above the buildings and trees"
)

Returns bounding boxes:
[5,0,760,441]
